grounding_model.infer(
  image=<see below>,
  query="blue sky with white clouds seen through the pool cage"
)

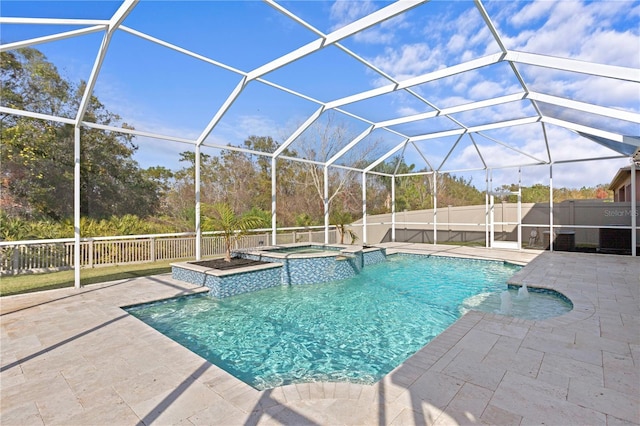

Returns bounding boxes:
[0,0,640,187]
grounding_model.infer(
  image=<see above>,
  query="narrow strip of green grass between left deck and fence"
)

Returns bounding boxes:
[0,260,176,296]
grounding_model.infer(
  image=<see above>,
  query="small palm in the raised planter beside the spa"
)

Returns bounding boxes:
[203,203,265,262]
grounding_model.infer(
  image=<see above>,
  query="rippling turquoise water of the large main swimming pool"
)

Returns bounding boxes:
[127,256,571,390]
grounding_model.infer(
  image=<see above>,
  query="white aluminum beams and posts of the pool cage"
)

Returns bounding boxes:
[0,0,640,287]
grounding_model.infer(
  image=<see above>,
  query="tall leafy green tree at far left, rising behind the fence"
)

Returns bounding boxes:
[0,49,159,220]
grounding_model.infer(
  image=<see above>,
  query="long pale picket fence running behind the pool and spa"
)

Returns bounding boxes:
[0,227,336,275]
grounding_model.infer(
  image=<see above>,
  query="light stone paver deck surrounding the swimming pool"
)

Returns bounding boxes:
[0,243,640,426]
